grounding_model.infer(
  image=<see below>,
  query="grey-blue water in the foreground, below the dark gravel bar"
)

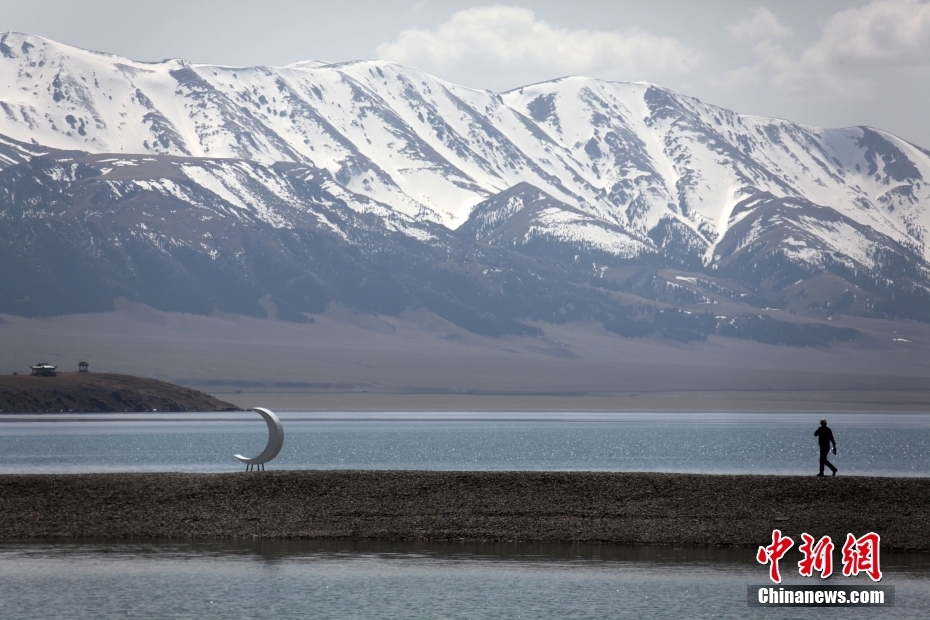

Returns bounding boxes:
[0,542,930,620]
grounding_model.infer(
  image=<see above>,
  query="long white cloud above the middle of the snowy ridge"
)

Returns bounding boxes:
[376,5,702,86]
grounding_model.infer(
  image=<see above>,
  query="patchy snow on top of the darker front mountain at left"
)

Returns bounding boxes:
[0,147,450,252]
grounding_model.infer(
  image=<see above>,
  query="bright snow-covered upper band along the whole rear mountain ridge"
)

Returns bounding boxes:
[0,33,930,266]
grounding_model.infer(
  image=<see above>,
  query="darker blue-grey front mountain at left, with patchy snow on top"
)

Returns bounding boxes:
[0,147,610,335]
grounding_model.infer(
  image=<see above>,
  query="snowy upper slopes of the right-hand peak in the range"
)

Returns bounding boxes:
[504,78,930,261]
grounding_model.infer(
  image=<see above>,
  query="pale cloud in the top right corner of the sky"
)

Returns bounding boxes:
[728,0,930,99]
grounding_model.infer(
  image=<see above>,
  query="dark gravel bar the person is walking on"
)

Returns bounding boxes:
[0,470,930,552]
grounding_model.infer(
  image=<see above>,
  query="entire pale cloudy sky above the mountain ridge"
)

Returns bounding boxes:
[0,0,930,148]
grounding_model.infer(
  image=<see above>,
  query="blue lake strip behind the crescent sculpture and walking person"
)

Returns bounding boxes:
[0,412,930,476]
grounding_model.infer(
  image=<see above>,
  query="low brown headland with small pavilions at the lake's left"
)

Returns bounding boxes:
[0,372,240,413]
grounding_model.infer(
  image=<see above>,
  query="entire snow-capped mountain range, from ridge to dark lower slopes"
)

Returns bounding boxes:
[0,33,930,343]
